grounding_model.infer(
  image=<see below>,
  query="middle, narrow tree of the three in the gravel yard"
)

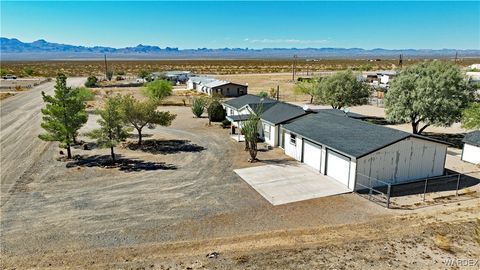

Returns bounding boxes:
[88,95,128,163]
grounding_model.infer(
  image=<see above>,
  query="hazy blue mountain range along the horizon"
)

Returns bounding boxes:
[0,37,480,60]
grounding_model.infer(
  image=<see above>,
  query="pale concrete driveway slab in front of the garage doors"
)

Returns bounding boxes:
[234,164,351,205]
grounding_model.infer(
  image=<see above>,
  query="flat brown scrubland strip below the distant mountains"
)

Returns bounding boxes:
[1,58,480,77]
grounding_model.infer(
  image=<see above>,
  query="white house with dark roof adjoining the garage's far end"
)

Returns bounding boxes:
[223,95,308,147]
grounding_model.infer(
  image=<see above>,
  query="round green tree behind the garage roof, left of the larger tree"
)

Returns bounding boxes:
[315,70,372,109]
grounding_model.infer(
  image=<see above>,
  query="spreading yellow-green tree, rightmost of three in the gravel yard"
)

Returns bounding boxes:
[123,95,176,145]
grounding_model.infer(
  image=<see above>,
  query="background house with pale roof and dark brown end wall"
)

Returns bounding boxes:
[187,77,248,97]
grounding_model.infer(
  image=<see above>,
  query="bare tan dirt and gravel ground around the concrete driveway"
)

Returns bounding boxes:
[0,75,480,269]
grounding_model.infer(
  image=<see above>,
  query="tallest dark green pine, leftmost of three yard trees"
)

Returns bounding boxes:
[39,74,88,158]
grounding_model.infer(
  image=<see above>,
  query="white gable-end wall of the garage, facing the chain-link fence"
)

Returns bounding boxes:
[356,137,447,186]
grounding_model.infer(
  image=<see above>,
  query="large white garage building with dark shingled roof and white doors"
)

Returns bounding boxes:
[280,110,447,190]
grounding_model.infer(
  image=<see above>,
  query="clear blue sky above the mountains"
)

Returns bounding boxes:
[0,0,480,49]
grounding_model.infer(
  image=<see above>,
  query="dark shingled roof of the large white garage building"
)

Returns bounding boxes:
[283,110,442,158]
